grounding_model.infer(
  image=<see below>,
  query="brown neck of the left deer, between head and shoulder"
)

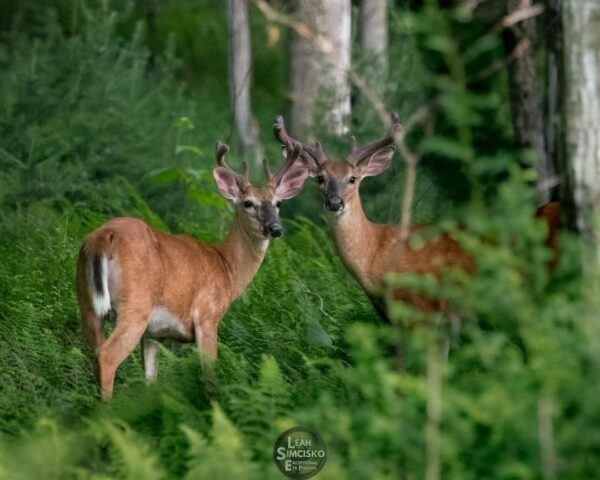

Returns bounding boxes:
[216,214,269,299]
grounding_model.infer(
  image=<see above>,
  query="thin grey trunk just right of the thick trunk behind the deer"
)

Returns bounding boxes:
[360,0,388,94]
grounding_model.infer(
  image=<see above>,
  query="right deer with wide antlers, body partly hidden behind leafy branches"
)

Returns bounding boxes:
[273,115,558,318]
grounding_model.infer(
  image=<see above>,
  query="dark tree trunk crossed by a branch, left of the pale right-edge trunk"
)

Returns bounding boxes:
[504,0,554,205]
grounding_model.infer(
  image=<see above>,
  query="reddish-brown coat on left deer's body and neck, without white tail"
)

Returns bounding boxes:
[77,212,267,398]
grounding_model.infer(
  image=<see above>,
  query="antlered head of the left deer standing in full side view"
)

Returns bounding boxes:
[213,142,309,239]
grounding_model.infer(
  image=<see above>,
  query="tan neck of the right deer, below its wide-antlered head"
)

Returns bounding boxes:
[329,192,379,292]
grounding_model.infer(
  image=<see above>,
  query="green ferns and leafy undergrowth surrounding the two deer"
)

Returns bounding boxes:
[0,2,600,480]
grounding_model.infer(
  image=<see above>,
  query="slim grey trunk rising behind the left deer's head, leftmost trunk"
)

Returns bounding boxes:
[228,0,262,162]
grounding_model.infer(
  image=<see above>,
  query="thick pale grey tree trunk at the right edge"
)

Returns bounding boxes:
[563,0,600,255]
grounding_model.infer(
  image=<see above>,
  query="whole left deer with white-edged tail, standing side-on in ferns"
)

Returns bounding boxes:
[77,142,308,400]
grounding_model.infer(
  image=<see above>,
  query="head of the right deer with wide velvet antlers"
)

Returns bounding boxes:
[273,113,402,215]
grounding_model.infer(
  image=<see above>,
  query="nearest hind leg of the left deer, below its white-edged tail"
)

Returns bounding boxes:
[98,310,149,400]
